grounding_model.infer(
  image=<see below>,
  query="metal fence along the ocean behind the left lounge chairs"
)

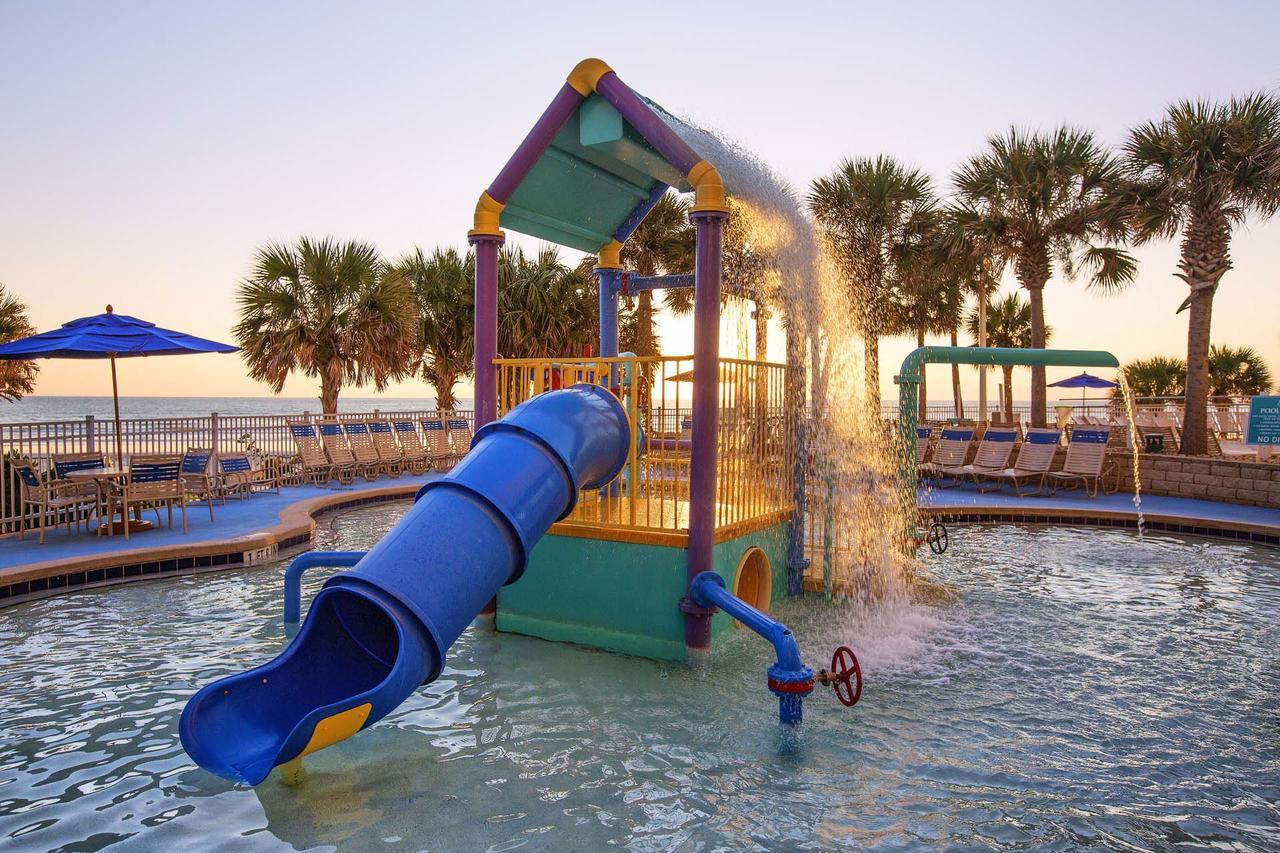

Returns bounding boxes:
[0,409,475,534]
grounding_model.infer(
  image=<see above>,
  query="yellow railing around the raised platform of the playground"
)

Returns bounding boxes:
[494,356,794,532]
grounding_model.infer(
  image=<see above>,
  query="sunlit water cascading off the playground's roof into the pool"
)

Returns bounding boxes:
[657,108,932,660]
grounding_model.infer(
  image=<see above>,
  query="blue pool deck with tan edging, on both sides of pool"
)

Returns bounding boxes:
[0,474,1280,607]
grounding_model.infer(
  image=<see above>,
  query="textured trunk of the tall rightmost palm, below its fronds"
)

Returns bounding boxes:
[1178,210,1231,456]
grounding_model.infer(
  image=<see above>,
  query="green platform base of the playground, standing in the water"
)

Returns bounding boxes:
[495,523,788,661]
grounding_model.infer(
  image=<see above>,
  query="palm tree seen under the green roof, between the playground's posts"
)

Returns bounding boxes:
[622,192,695,355]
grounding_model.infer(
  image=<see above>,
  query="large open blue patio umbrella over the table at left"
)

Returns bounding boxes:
[0,305,239,467]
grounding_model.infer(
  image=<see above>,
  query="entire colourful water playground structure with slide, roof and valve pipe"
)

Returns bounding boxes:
[179,59,861,784]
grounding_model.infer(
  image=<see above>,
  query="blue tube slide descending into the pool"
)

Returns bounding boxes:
[178,386,630,785]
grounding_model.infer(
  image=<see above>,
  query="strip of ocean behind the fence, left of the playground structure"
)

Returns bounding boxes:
[0,394,471,424]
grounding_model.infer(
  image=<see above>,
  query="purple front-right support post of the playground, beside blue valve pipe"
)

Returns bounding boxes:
[680,210,728,654]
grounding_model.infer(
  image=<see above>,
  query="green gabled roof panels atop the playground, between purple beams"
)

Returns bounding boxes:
[500,95,687,252]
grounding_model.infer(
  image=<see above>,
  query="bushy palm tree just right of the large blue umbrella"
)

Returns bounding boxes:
[234,237,417,414]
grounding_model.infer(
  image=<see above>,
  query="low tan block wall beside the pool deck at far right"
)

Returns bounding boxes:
[1115,453,1280,507]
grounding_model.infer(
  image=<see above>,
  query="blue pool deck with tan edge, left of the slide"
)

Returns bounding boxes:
[0,473,439,607]
